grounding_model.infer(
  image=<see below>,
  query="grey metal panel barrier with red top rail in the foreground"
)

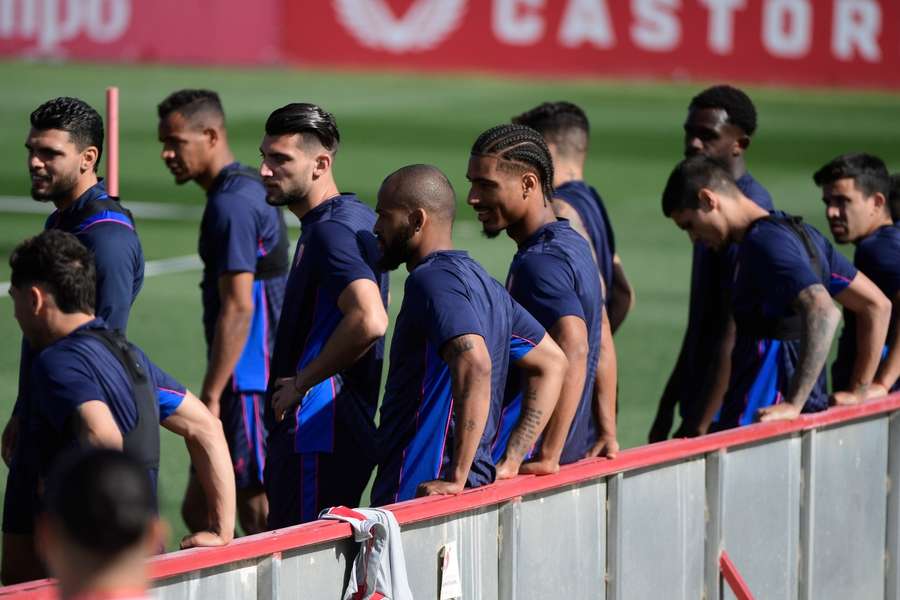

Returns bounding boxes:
[0,394,900,600]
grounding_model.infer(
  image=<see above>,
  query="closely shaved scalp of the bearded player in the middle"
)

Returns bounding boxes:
[379,165,456,223]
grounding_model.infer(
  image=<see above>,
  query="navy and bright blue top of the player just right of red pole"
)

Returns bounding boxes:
[198,163,289,392]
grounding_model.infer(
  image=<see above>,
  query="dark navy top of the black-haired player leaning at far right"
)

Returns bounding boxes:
[831,224,900,392]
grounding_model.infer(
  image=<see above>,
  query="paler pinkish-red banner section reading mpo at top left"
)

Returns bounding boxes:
[0,0,281,64]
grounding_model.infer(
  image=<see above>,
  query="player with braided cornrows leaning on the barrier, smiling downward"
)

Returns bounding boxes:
[466,124,618,473]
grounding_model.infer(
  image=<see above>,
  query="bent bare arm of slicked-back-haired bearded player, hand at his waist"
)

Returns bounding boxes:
[272,279,387,421]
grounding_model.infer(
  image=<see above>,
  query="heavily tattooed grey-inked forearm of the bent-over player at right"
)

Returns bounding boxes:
[759,283,841,421]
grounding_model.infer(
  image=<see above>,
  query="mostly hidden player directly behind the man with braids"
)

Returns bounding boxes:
[512,102,634,333]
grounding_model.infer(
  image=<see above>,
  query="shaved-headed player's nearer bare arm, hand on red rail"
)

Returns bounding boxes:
[416,334,491,496]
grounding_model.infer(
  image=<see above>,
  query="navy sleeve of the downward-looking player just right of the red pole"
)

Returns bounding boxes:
[206,192,260,277]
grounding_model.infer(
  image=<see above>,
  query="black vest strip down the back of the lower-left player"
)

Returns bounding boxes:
[78,329,159,469]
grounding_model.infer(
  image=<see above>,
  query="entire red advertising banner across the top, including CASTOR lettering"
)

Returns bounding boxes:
[0,0,900,88]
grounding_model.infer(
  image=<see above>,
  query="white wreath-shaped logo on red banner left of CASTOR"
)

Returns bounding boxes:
[334,0,466,54]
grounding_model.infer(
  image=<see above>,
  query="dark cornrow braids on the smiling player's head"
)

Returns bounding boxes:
[472,123,553,201]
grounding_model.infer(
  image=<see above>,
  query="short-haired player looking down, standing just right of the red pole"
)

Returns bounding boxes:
[157,90,289,534]
